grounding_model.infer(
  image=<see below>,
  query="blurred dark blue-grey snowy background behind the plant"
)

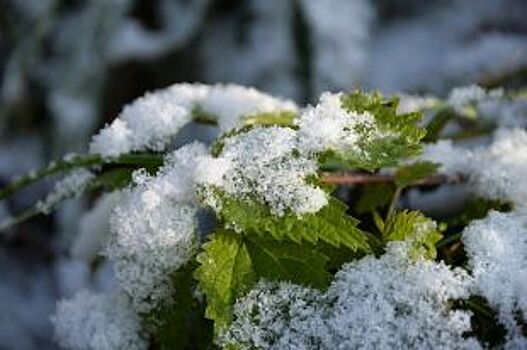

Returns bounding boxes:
[0,0,527,350]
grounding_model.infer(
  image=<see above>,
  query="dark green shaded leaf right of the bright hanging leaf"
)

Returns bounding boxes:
[246,236,331,289]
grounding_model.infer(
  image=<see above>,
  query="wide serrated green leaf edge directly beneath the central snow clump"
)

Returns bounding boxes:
[217,190,380,253]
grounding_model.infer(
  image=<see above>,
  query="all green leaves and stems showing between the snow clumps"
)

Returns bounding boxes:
[7,85,525,349]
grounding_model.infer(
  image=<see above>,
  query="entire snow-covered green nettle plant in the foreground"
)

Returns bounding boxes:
[0,84,527,349]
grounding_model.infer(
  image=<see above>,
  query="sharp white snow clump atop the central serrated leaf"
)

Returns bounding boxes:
[197,127,327,215]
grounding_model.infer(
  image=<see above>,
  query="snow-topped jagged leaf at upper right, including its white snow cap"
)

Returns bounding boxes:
[297,92,424,170]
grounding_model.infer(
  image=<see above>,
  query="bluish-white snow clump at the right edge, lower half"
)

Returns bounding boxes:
[463,212,527,347]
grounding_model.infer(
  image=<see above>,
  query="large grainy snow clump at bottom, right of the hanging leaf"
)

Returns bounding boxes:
[221,242,480,349]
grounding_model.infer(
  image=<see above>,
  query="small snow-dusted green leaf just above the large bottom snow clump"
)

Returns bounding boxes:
[383,210,442,259]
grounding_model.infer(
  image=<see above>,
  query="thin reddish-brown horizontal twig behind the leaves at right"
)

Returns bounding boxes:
[322,172,465,186]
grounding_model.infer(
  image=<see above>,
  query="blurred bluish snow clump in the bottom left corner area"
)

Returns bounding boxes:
[51,290,148,350]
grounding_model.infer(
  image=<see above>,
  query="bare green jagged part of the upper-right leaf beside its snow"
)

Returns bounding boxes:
[339,92,426,170]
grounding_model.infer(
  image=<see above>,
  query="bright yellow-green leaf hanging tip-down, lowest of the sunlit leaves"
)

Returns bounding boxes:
[196,231,258,335]
